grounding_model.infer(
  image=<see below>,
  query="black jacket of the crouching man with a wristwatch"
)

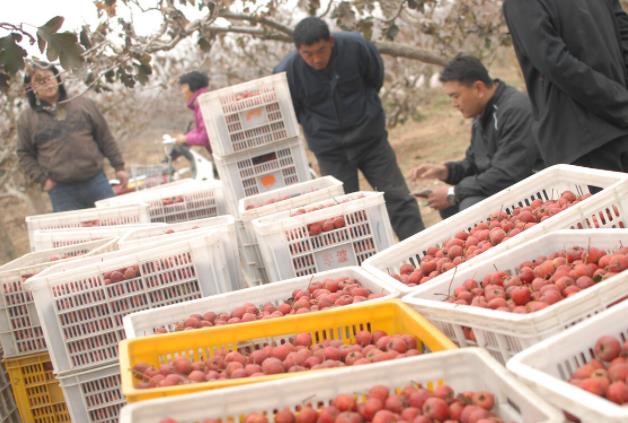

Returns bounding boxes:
[446,80,539,201]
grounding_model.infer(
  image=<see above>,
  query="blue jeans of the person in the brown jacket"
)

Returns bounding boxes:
[48,172,114,212]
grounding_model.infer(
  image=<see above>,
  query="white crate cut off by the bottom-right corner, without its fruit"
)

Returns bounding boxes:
[508,301,628,423]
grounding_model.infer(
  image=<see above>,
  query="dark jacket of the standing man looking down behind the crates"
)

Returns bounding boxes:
[273,32,386,156]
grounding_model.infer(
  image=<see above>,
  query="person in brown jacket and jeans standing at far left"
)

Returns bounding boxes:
[17,64,128,212]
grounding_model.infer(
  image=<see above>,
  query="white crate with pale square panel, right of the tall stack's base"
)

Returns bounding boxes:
[253,192,394,281]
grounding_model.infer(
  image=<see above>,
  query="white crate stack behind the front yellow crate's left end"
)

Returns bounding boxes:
[24,230,239,423]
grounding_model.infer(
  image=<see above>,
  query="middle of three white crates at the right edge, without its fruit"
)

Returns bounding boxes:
[403,229,628,363]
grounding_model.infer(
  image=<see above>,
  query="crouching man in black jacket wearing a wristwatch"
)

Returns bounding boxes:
[410,55,539,218]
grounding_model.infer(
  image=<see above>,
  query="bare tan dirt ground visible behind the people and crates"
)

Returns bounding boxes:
[0,58,522,263]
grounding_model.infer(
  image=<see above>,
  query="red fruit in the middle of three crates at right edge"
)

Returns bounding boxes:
[445,247,628,313]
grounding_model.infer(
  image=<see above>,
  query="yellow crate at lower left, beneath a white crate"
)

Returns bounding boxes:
[4,353,71,423]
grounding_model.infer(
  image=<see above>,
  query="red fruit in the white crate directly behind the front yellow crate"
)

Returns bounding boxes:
[155,277,386,333]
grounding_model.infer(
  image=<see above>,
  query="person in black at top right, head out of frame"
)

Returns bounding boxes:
[504,0,628,172]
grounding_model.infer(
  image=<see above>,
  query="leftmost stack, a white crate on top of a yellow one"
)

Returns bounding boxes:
[0,239,115,423]
